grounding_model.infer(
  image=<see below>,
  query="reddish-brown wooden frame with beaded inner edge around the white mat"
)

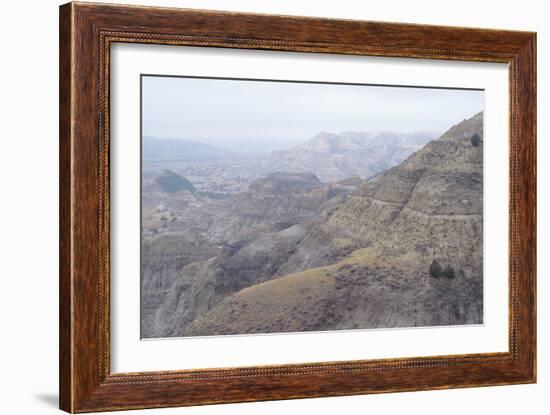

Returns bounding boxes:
[59,3,536,412]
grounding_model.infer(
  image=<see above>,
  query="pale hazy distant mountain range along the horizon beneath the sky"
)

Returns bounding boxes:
[143,131,437,183]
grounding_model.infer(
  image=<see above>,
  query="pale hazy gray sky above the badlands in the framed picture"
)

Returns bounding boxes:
[142,76,483,148]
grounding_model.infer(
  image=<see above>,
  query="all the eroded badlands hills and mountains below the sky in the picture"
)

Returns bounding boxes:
[141,113,483,338]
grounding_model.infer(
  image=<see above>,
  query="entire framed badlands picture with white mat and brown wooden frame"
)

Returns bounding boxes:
[60,3,536,412]
